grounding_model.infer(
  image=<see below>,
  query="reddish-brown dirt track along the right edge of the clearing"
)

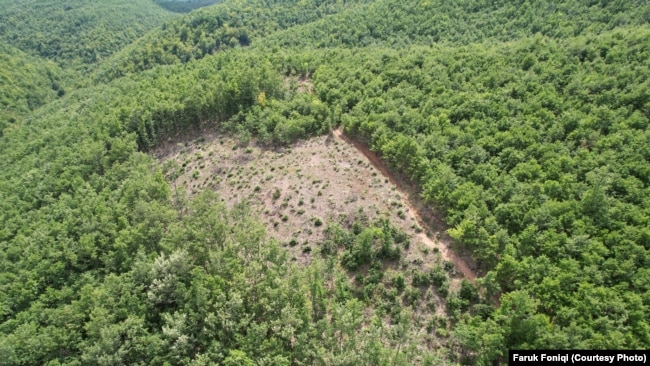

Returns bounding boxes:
[333,128,477,282]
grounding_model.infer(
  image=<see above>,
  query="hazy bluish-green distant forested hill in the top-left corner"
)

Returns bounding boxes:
[0,0,174,68]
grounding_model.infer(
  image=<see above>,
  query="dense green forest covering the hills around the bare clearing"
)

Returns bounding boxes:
[0,0,650,365]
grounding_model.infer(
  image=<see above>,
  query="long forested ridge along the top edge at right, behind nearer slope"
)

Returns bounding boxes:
[258,0,650,48]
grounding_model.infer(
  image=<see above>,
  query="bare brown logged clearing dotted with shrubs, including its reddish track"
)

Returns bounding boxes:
[154,130,476,284]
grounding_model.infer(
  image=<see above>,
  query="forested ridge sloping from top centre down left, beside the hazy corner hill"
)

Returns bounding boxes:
[93,0,370,81]
